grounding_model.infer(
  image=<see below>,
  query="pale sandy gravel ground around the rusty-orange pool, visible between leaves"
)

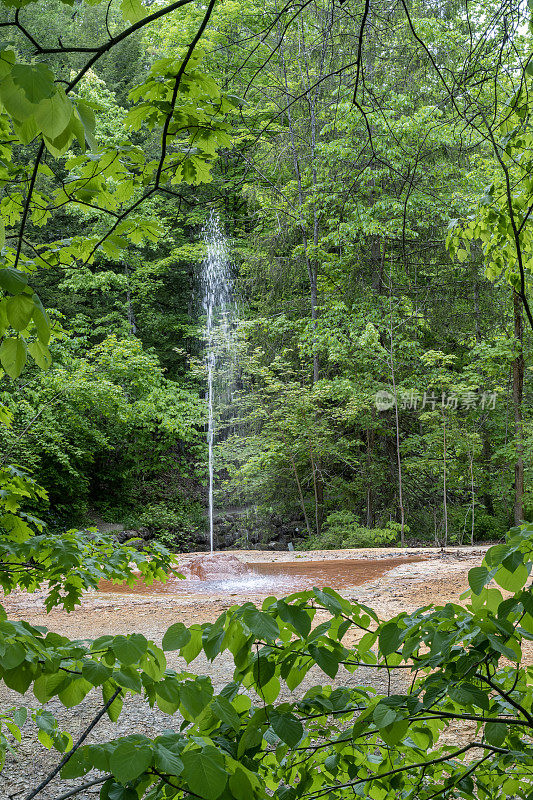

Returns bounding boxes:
[0,547,508,800]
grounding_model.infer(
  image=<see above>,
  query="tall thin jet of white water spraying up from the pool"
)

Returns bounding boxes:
[202,211,235,552]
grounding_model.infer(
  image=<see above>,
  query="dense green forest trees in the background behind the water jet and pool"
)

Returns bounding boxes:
[0,2,533,549]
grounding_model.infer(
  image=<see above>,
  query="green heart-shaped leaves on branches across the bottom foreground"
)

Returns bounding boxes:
[0,526,533,800]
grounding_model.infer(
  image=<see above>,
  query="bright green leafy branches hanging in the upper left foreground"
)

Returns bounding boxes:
[0,0,235,378]
